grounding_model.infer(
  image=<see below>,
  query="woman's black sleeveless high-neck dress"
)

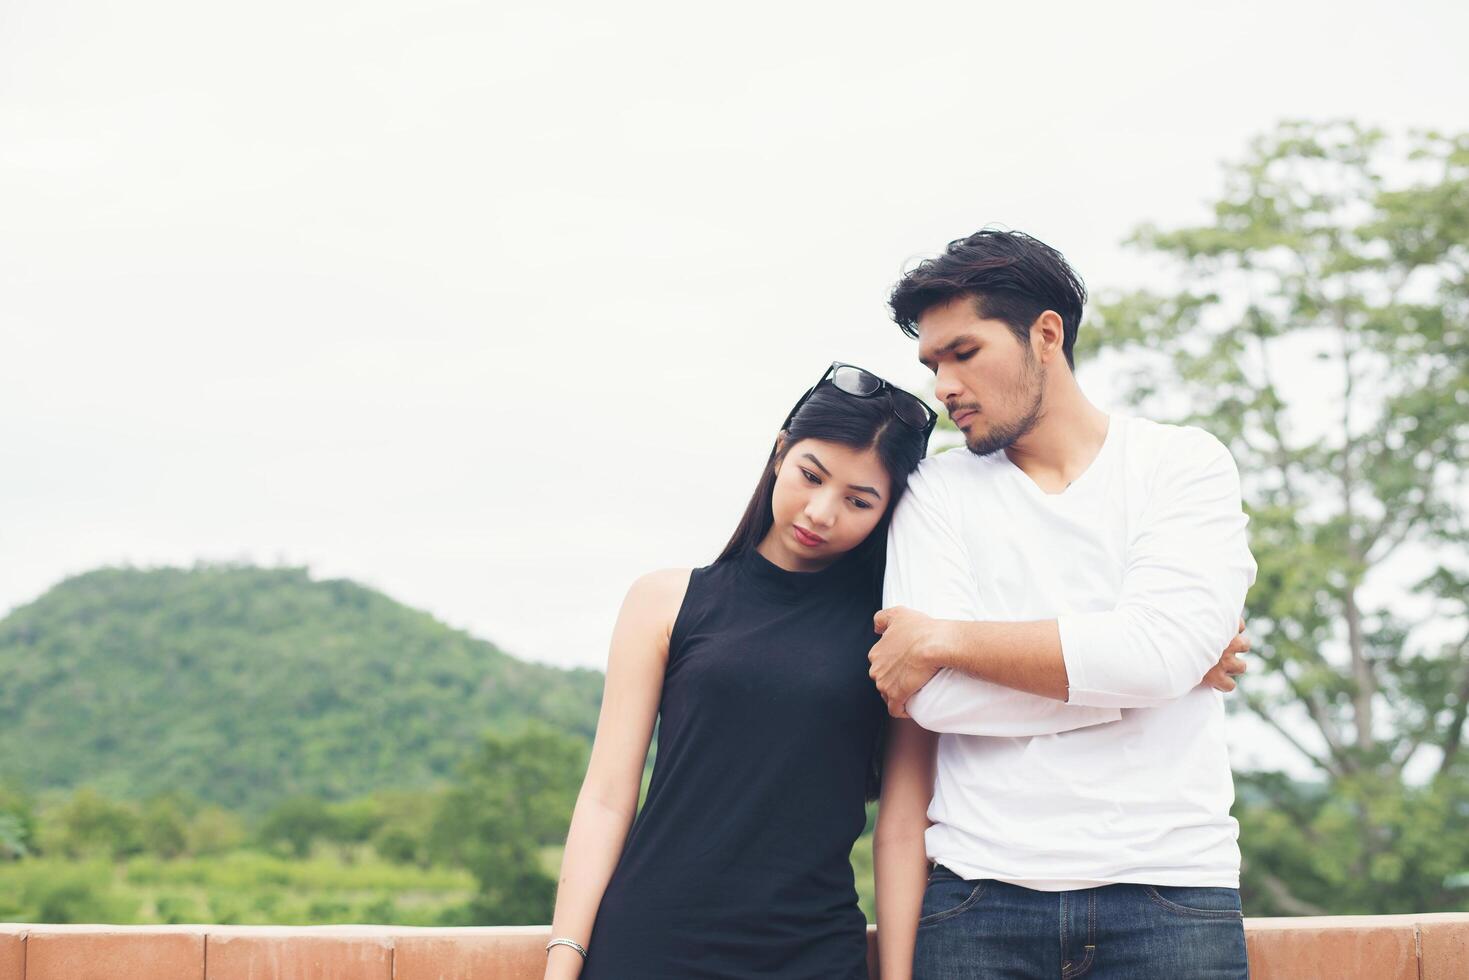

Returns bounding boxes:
[582,551,886,980]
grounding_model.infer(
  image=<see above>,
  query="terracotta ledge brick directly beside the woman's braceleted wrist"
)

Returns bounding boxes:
[392,926,551,980]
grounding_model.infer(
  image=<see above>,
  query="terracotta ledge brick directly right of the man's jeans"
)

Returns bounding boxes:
[1244,915,1418,980]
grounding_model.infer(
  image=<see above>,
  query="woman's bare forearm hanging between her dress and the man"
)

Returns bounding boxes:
[873,718,939,980]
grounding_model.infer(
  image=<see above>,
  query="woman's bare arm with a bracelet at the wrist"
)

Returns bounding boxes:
[545,569,689,980]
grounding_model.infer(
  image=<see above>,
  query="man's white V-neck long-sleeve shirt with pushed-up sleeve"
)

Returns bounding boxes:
[884,416,1255,890]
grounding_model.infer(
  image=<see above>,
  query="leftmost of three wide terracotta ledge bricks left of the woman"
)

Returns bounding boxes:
[25,926,204,980]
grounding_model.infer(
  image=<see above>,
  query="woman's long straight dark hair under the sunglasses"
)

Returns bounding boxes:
[715,382,927,799]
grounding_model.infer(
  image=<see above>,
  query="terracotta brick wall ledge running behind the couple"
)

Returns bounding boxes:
[0,912,1469,980]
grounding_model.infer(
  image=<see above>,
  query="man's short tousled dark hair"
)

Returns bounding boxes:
[889,228,1087,370]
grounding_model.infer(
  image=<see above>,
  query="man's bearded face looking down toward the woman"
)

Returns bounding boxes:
[918,297,1046,455]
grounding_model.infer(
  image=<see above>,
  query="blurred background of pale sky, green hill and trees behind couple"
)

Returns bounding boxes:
[0,0,1469,924]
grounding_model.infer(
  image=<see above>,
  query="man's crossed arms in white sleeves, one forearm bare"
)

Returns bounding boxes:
[870,430,1255,735]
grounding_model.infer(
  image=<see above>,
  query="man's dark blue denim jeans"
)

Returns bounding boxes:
[914,864,1250,980]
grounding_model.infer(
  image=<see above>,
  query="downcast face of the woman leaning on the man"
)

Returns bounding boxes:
[759,439,892,572]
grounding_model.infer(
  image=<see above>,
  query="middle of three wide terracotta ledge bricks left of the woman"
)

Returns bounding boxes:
[207,926,392,980]
